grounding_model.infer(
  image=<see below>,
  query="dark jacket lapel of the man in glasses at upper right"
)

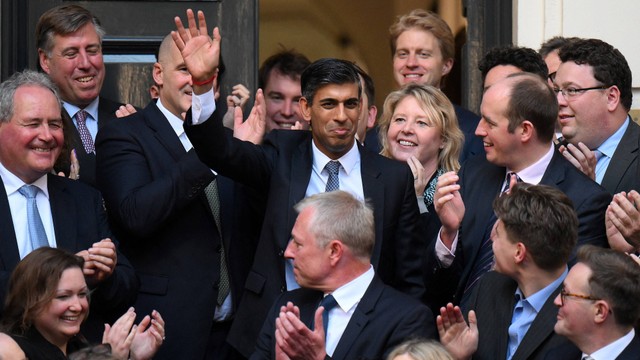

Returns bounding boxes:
[601,120,640,193]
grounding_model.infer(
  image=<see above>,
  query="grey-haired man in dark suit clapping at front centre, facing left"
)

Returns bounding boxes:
[251,191,435,360]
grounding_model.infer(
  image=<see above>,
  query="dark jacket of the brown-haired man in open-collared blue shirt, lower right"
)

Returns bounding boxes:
[463,271,573,360]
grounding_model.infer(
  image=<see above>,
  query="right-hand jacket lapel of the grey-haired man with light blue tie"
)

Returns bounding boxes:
[47,174,79,249]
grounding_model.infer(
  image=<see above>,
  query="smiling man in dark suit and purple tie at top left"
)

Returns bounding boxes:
[36,4,122,186]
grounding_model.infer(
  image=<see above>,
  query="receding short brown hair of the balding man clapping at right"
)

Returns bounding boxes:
[505,72,558,141]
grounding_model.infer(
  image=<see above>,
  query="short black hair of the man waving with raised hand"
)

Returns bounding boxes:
[300,58,362,105]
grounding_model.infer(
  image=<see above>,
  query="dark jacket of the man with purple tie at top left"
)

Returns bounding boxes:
[55,97,123,187]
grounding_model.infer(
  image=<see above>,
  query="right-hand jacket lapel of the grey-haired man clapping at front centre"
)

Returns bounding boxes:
[332,276,384,359]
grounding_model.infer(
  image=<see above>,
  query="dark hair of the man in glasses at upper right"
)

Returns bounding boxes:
[558,39,633,111]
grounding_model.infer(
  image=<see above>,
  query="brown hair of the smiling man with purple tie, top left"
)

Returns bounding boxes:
[36,4,105,57]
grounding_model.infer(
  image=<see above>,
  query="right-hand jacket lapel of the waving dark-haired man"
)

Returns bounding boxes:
[358,144,385,268]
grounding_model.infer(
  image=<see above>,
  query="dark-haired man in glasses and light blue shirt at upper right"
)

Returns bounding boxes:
[553,39,640,251]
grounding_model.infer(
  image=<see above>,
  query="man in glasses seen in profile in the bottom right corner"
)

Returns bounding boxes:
[549,246,640,360]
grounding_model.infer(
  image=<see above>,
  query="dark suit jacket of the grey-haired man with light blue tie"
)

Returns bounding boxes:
[0,175,139,343]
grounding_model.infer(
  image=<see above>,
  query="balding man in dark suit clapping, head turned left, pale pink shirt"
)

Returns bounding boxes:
[427,73,611,303]
